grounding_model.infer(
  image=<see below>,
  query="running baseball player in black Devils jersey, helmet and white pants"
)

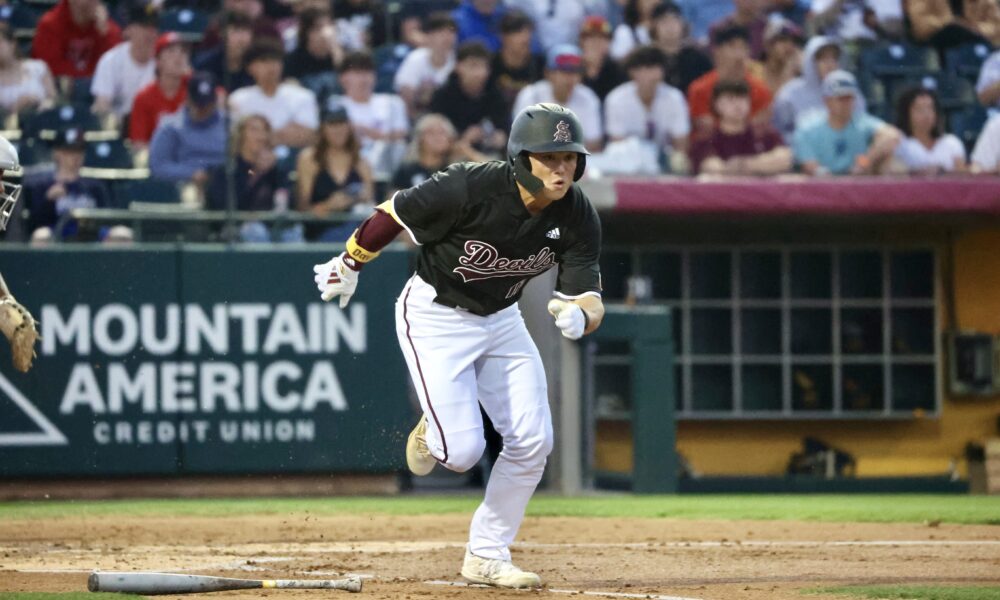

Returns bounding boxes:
[313,104,604,588]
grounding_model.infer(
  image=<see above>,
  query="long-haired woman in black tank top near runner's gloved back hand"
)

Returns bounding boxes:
[296,107,375,242]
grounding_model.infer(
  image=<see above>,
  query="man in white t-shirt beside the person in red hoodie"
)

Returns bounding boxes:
[90,5,159,117]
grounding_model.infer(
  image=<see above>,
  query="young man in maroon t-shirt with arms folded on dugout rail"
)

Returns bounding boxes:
[690,80,792,176]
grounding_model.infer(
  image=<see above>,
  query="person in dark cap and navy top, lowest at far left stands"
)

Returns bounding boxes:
[24,127,109,240]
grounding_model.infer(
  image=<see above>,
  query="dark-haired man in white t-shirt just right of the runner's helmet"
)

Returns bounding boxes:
[604,46,691,153]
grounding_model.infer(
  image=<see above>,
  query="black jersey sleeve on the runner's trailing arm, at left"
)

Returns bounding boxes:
[392,163,468,244]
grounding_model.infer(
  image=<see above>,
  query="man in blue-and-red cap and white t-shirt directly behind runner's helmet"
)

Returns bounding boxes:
[511,44,604,152]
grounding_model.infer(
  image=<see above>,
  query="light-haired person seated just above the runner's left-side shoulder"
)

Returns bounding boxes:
[392,113,488,190]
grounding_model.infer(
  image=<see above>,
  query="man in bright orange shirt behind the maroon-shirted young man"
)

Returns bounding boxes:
[688,27,771,135]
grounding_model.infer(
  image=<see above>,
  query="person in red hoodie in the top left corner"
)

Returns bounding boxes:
[31,0,122,78]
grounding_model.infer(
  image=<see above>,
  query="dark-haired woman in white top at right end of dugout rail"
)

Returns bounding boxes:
[896,87,969,175]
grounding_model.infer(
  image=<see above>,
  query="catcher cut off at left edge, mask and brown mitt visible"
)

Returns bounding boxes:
[0,137,38,372]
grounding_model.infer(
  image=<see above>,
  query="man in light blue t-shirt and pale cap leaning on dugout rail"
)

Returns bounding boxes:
[792,69,902,175]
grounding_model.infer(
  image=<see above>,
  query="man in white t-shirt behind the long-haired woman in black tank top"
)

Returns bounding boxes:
[331,52,410,181]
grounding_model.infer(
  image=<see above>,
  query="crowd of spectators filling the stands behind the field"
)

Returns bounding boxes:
[0,0,1000,241]
